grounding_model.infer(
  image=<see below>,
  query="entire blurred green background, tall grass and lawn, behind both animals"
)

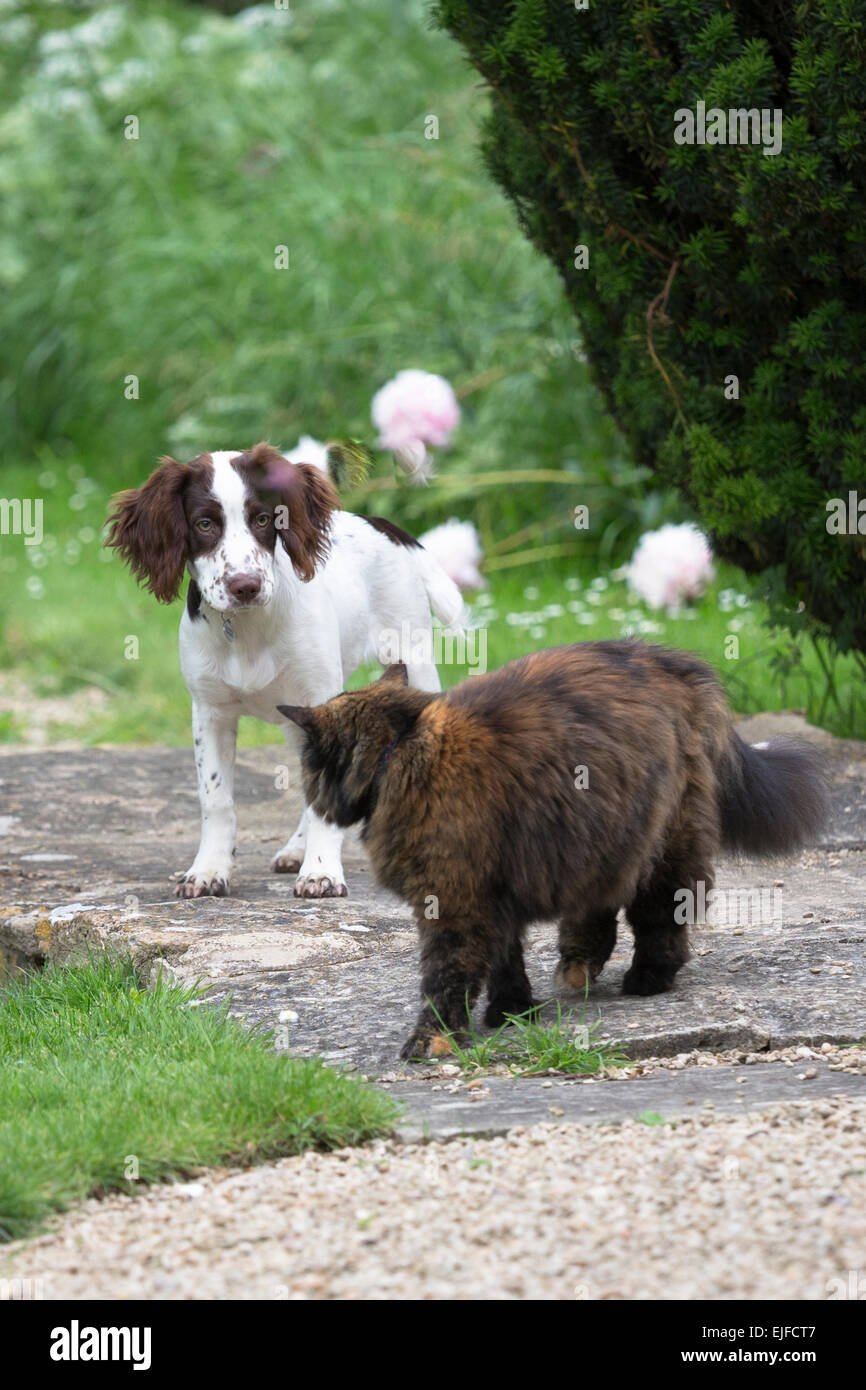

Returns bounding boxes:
[0,0,866,744]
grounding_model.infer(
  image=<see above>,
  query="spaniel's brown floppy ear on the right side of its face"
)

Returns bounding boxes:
[246,443,339,584]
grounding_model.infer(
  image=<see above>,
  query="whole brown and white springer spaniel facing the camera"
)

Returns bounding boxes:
[106,443,463,898]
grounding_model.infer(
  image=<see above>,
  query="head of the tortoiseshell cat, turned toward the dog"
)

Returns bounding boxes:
[277,662,435,826]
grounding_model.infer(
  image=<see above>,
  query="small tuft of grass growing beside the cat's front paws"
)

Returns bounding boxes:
[428,1002,628,1076]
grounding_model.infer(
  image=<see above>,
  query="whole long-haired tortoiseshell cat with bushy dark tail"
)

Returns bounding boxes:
[281,641,827,1056]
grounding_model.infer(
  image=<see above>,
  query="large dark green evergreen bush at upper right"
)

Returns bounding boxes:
[435,0,866,652]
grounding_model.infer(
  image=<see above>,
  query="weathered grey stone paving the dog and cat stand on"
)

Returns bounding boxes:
[0,716,866,1128]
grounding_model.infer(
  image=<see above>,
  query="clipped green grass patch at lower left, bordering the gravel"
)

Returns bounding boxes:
[0,958,398,1240]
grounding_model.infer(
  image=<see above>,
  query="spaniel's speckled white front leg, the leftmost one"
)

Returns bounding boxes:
[175,701,238,898]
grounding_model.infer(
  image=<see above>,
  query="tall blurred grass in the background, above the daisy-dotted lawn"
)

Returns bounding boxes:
[0,0,670,550]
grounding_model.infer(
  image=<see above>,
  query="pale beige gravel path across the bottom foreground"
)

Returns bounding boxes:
[0,1099,866,1300]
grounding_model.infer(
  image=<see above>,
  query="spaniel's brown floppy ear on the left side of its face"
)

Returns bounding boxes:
[106,459,190,603]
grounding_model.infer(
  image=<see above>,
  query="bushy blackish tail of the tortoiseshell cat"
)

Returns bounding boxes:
[719,730,830,855]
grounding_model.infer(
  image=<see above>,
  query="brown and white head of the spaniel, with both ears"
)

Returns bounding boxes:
[106,443,339,613]
